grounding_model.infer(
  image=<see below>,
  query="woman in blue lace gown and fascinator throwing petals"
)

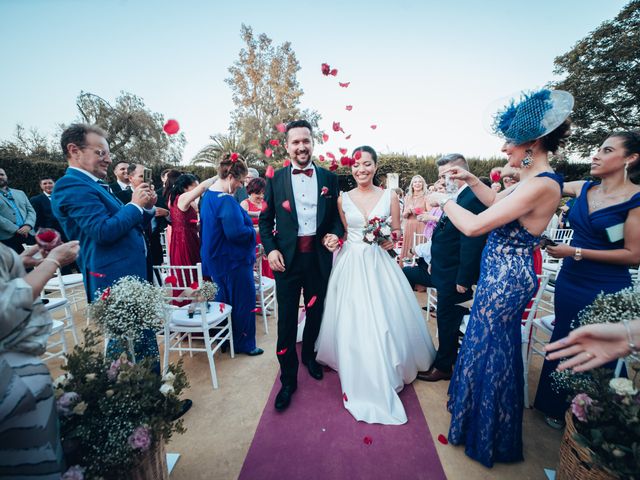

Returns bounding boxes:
[429,90,573,467]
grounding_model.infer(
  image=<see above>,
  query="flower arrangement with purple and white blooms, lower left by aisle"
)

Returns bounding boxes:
[54,329,189,480]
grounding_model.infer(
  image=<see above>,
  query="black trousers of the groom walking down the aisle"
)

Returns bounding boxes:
[274,252,328,385]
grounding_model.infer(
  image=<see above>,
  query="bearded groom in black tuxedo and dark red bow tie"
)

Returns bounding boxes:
[260,120,344,411]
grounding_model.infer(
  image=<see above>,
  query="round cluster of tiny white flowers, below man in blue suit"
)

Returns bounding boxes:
[89,276,164,340]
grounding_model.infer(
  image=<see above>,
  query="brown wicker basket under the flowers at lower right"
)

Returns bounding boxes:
[556,410,616,480]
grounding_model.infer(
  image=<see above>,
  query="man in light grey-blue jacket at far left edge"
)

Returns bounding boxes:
[0,168,36,253]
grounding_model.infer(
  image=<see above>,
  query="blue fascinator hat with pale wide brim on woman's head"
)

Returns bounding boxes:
[493,89,574,145]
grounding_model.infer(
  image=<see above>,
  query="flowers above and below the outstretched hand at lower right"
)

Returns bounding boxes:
[552,288,640,480]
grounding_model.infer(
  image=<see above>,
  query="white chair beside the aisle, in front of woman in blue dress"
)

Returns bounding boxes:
[153,263,235,389]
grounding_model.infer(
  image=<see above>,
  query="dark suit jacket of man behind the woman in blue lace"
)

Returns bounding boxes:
[431,187,487,288]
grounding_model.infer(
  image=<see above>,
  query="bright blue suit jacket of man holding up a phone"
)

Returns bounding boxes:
[51,168,151,301]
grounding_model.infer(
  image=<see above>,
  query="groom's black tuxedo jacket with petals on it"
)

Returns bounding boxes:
[259,165,344,279]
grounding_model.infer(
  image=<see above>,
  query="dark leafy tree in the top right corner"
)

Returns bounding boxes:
[554,0,640,156]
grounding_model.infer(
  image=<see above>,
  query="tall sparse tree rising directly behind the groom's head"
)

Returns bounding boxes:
[225,24,320,164]
